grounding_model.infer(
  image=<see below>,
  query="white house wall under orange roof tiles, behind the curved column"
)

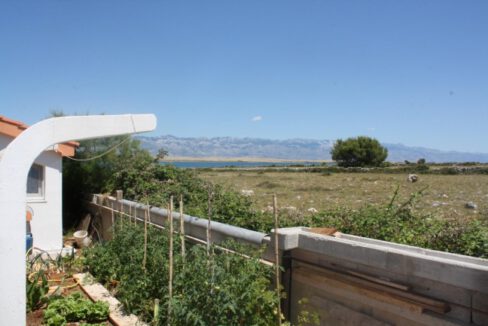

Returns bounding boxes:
[0,135,63,250]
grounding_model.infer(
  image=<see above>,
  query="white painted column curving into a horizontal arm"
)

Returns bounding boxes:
[0,114,156,326]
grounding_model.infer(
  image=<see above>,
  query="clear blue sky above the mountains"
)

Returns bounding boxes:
[0,0,488,152]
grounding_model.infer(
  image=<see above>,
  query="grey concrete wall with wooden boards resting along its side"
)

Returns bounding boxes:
[279,228,488,325]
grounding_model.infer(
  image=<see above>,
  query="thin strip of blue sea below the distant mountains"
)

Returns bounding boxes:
[161,161,321,169]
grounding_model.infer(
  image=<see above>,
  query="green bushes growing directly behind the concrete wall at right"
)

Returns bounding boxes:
[284,189,488,258]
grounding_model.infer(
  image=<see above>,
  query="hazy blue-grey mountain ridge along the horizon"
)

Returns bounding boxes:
[137,135,488,163]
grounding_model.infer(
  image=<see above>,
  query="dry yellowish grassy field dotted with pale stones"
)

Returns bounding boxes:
[199,170,488,219]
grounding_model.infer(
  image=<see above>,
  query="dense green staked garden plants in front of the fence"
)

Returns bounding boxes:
[85,222,278,325]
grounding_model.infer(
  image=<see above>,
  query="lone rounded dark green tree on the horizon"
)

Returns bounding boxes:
[331,136,388,167]
